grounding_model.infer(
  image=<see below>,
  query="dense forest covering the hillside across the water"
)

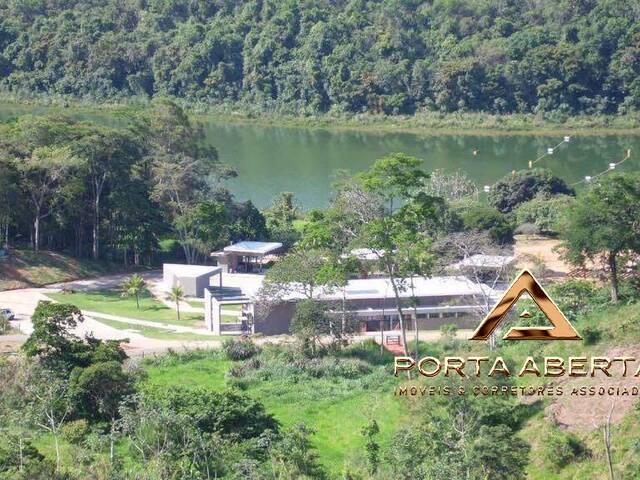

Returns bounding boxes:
[0,0,640,114]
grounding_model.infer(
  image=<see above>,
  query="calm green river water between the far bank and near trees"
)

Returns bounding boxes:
[0,106,640,208]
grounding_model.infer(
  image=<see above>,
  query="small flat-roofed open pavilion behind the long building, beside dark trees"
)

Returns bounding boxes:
[211,241,282,273]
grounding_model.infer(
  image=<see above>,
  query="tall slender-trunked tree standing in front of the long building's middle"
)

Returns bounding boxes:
[334,153,446,354]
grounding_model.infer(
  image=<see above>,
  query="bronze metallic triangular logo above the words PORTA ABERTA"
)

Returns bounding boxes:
[471,269,582,340]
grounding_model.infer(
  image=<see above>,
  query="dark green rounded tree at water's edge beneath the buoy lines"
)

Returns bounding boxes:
[488,169,575,213]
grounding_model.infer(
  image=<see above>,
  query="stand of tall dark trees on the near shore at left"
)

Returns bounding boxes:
[0,100,292,265]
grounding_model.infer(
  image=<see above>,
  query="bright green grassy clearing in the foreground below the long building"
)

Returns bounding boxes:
[146,345,409,474]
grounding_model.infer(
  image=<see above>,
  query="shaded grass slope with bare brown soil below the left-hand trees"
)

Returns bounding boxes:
[0,250,139,291]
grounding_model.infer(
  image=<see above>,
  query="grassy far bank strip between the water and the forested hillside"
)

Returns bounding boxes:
[0,95,640,135]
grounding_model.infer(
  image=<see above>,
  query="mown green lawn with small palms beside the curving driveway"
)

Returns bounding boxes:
[47,290,204,327]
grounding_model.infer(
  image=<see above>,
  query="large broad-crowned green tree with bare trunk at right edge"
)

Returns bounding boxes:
[560,173,640,303]
